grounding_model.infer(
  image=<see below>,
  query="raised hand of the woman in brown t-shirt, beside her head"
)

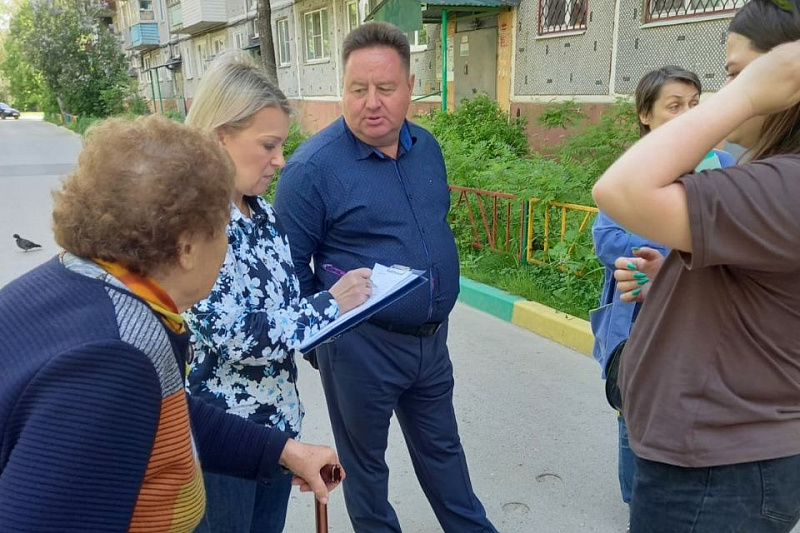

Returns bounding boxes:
[726,41,800,116]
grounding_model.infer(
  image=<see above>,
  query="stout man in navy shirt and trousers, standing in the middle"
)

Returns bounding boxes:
[274,23,496,533]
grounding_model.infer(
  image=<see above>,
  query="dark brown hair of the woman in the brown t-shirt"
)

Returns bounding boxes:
[728,0,800,160]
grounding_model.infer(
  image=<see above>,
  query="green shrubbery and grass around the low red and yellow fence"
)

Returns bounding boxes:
[417,97,638,318]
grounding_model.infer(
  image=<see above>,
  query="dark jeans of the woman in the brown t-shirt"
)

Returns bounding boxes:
[631,455,800,533]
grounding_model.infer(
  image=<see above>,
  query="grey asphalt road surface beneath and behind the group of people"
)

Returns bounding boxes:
[0,119,627,533]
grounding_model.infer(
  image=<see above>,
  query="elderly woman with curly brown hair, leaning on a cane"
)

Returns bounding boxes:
[0,116,338,533]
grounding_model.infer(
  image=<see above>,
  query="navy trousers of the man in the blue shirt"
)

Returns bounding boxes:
[318,323,496,533]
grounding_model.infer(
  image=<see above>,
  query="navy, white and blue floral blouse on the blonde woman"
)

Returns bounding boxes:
[184,197,339,437]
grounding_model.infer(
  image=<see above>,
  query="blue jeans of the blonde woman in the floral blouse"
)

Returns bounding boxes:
[194,472,292,533]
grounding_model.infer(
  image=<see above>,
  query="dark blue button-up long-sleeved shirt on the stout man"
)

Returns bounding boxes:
[273,118,459,326]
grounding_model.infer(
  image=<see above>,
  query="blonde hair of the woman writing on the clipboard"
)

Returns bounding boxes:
[186,52,292,131]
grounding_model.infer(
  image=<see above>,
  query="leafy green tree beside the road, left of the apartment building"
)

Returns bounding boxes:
[2,0,132,117]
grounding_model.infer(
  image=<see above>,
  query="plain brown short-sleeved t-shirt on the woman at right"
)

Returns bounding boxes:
[619,156,800,467]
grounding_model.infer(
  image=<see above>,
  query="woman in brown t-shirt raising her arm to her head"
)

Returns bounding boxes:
[594,0,800,533]
